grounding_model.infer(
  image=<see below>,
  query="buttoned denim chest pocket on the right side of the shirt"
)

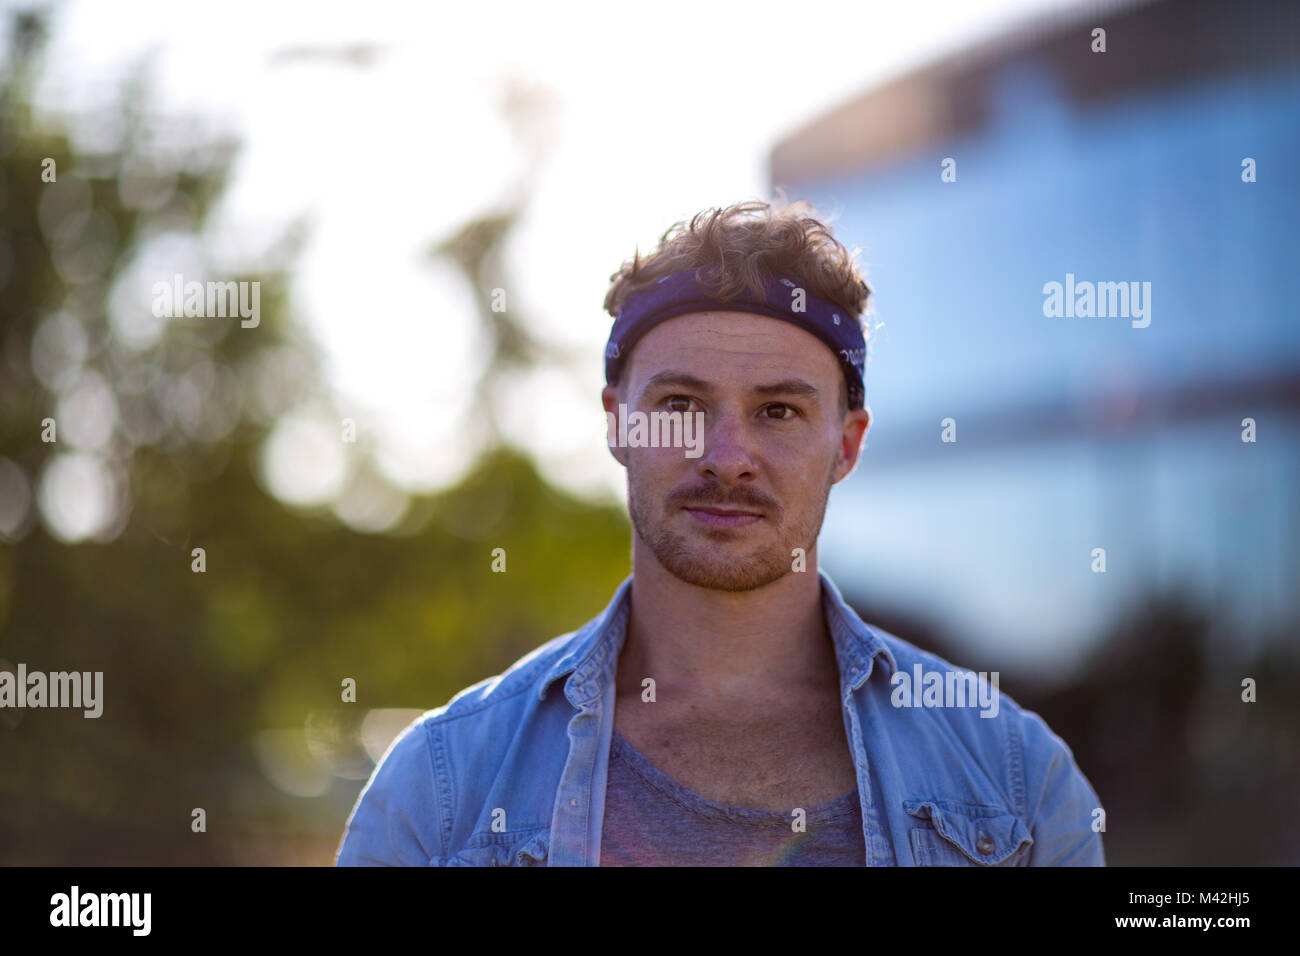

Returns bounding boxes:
[904,800,1034,866]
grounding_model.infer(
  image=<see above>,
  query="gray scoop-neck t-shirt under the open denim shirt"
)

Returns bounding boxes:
[601,731,867,866]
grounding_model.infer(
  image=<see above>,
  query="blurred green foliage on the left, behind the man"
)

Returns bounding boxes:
[0,7,628,864]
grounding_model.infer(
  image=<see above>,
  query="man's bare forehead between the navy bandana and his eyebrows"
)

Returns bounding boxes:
[628,312,840,386]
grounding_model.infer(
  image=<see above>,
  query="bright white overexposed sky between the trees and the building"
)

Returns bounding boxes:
[40,0,1075,522]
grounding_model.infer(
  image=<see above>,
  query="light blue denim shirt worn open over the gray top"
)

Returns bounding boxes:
[337,572,1105,866]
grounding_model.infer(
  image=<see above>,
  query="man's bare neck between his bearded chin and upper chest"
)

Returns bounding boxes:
[619,541,839,706]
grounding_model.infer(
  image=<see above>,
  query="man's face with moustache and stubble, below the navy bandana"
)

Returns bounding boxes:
[602,312,870,591]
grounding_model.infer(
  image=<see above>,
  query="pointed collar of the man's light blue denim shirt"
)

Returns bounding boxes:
[537,570,898,710]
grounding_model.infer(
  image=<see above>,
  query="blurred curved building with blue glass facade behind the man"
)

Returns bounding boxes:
[771,0,1300,672]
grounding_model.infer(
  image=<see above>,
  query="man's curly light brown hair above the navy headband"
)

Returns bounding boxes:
[605,199,871,325]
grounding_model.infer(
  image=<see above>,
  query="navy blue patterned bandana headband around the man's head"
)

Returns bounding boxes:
[605,269,867,408]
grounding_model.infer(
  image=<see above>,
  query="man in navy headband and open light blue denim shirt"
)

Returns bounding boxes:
[338,203,1104,866]
